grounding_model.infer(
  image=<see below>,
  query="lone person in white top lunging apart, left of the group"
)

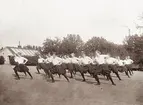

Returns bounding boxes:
[13,53,33,79]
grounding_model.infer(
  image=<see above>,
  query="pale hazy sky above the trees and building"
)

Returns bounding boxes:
[0,0,143,46]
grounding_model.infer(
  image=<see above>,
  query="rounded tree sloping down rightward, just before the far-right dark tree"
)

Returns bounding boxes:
[84,37,127,59]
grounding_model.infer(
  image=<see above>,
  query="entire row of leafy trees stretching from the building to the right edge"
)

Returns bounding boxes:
[23,34,143,65]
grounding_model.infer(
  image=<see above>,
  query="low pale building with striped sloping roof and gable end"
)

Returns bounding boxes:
[0,47,39,64]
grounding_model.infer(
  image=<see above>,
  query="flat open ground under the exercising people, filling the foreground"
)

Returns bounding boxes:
[0,65,143,105]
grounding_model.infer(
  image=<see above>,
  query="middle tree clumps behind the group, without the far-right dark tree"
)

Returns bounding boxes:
[42,34,128,58]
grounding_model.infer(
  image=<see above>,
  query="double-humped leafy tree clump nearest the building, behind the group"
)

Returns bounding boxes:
[43,34,83,55]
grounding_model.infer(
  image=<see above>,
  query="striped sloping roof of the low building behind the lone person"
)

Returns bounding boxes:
[6,47,39,56]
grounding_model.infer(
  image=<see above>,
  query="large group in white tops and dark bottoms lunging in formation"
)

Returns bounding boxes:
[36,51,133,85]
